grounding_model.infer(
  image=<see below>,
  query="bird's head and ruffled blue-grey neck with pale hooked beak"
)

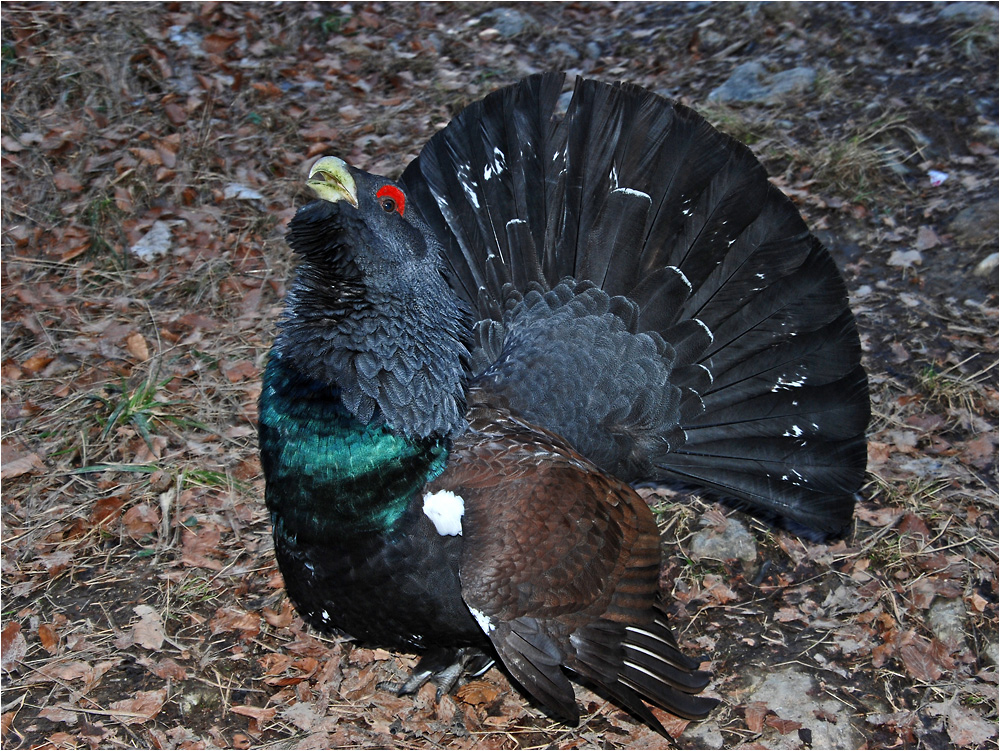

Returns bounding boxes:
[275,157,468,436]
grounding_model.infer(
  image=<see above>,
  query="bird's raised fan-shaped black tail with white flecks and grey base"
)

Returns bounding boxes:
[402,75,869,531]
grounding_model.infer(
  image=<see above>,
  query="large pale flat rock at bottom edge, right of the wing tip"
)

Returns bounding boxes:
[747,666,864,749]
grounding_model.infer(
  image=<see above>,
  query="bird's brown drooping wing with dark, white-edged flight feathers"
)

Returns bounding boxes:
[429,406,712,726]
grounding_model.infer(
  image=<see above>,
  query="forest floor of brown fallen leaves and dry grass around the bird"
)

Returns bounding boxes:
[0,2,998,749]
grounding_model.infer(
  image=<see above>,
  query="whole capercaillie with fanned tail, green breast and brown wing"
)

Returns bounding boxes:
[258,73,870,733]
